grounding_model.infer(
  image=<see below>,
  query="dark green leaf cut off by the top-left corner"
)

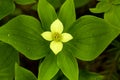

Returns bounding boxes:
[0,0,15,20]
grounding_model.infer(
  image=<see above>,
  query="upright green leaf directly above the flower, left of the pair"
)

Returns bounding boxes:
[38,0,57,31]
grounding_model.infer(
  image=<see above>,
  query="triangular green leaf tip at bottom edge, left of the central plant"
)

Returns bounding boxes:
[15,64,37,80]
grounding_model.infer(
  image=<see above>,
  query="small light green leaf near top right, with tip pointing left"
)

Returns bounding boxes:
[90,1,112,13]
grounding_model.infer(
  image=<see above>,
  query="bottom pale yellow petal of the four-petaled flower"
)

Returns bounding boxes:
[50,41,63,55]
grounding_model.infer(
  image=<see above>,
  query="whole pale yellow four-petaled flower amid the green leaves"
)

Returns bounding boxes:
[41,19,73,55]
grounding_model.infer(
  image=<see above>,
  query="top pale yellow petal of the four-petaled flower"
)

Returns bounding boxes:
[50,19,63,33]
